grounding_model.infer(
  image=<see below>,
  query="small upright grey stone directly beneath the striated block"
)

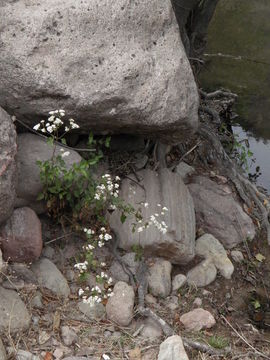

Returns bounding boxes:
[148,259,172,298]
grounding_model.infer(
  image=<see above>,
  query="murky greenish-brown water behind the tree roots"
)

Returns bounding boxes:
[200,0,270,192]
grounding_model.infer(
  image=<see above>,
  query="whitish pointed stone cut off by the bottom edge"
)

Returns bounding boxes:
[158,335,189,360]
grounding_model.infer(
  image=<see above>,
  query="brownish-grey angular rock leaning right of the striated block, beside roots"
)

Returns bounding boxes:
[188,176,255,249]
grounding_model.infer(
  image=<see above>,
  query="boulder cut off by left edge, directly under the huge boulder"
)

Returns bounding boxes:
[0,107,17,224]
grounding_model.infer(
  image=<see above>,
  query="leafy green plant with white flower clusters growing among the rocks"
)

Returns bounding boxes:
[34,110,168,306]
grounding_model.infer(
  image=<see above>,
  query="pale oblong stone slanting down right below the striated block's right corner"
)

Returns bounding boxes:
[195,234,234,279]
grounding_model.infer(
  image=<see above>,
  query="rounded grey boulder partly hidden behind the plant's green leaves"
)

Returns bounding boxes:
[16,133,81,207]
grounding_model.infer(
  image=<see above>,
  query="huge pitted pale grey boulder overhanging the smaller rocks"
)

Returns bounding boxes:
[0,0,198,139]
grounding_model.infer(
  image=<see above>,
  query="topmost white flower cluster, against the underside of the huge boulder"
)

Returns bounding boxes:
[33,109,79,134]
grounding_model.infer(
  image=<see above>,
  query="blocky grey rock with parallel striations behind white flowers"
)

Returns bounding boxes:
[110,169,195,264]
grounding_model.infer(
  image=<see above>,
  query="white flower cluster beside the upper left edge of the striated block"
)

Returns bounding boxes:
[94,174,120,202]
